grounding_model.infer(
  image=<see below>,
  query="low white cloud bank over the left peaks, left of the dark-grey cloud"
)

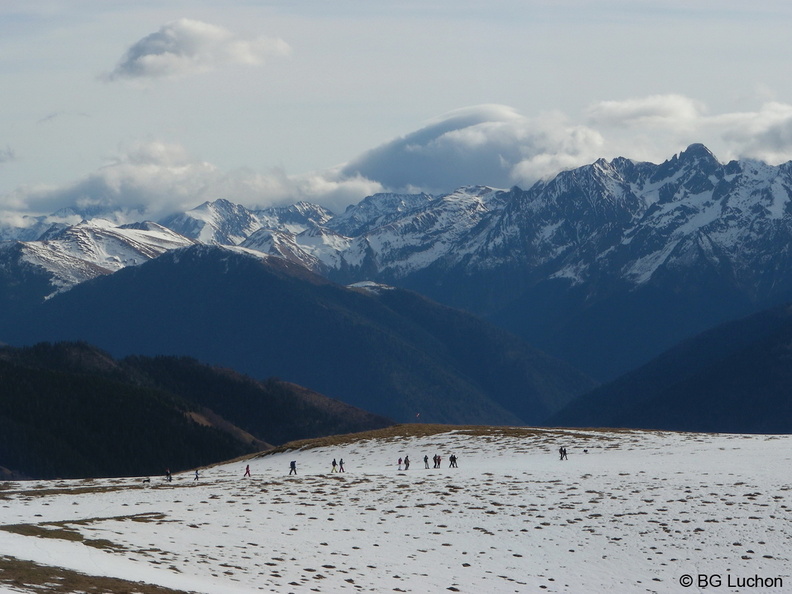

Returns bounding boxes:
[0,141,383,223]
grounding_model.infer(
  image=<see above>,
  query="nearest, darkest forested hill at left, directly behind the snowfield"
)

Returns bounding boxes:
[0,350,257,478]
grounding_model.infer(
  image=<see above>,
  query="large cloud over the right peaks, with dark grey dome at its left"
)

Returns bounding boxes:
[340,94,792,192]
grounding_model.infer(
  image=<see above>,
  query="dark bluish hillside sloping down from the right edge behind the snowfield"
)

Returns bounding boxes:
[548,305,792,433]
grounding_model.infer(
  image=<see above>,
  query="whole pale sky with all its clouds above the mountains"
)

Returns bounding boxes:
[0,0,792,222]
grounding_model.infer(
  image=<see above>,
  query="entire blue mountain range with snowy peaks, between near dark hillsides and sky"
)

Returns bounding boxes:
[0,144,792,430]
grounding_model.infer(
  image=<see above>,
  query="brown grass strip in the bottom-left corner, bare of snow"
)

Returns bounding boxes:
[0,556,187,594]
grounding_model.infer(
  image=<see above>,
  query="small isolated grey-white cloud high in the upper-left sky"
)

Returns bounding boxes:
[102,19,291,81]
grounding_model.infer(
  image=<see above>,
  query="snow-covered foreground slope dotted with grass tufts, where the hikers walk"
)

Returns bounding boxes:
[0,426,792,594]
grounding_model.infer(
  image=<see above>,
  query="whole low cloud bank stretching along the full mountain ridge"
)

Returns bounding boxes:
[0,95,792,221]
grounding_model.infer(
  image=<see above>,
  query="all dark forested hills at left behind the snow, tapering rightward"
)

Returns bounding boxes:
[0,343,390,478]
